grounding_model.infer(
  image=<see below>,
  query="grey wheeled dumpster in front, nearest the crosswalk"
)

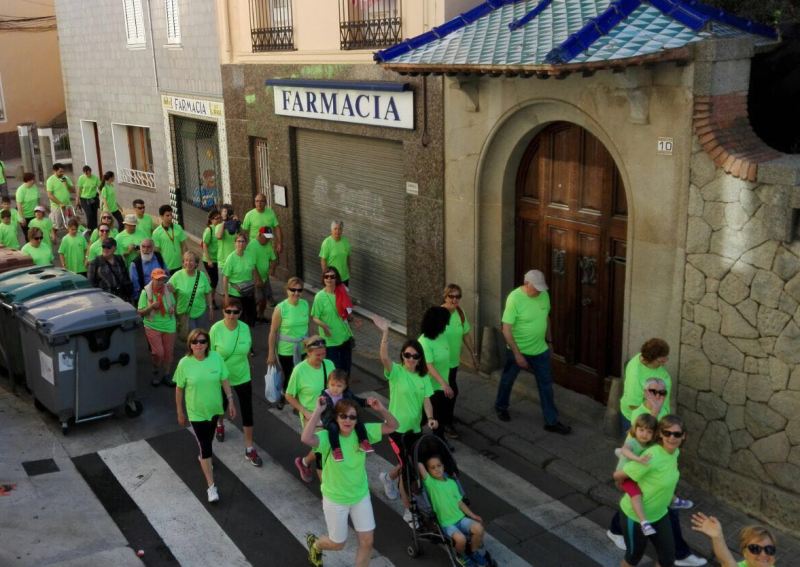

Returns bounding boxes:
[16,288,142,434]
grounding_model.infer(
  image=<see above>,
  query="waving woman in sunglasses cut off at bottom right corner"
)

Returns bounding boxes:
[692,512,778,567]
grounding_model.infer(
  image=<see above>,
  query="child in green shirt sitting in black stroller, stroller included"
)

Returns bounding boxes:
[412,435,496,566]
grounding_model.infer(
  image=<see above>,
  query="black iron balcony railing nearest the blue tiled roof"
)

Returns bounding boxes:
[339,0,402,49]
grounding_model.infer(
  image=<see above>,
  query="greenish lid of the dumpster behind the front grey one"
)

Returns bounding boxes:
[0,266,89,305]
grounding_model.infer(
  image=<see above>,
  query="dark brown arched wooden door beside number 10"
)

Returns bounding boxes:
[515,122,628,402]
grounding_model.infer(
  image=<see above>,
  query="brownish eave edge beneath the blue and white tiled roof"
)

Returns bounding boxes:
[381,45,692,77]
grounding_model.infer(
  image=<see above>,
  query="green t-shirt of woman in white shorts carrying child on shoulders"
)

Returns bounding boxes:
[316,423,383,506]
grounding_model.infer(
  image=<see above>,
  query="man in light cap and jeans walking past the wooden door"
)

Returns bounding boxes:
[494,270,572,435]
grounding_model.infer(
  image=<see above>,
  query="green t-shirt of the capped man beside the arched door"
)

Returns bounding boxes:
[502,287,550,356]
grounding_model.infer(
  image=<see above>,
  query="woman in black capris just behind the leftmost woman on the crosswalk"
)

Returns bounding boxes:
[209,297,261,467]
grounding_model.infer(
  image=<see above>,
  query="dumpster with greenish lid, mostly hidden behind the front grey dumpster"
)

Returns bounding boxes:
[0,266,90,388]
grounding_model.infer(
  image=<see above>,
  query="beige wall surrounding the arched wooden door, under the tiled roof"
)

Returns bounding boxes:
[445,64,692,378]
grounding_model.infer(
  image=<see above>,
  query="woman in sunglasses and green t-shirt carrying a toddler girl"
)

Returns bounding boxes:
[613,415,686,567]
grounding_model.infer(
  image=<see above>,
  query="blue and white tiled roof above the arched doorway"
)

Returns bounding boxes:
[375,0,776,67]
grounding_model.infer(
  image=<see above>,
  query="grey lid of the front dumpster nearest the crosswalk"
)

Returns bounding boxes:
[17,288,138,336]
